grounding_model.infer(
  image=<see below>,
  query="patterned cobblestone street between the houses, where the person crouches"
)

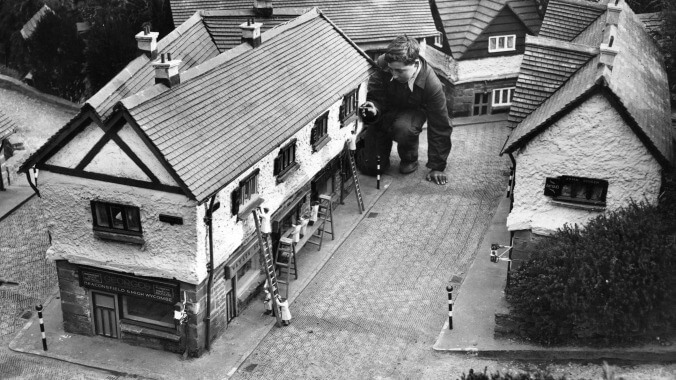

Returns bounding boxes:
[232,125,509,379]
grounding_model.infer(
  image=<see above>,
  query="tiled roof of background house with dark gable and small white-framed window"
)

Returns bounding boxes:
[436,0,541,59]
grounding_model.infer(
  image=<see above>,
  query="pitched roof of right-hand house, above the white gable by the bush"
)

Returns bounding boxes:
[503,0,674,166]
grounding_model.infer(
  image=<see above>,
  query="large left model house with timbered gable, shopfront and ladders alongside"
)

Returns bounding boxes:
[22,9,374,356]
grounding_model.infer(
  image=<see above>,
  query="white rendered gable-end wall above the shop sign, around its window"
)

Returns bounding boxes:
[39,171,199,283]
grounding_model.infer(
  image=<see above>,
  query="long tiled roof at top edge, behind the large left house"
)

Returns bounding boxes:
[171,0,437,44]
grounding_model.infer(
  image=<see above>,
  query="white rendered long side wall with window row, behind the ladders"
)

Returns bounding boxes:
[197,83,366,279]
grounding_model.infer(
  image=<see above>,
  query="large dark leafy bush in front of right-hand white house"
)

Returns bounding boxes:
[507,202,676,344]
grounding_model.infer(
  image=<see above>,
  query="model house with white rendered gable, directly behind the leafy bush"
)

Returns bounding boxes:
[502,0,674,240]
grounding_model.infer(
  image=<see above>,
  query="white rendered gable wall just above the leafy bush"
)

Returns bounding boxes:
[507,95,661,234]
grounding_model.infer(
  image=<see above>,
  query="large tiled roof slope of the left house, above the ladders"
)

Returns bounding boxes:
[118,9,375,201]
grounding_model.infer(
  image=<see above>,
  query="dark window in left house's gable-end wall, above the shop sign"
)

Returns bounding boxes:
[91,201,141,235]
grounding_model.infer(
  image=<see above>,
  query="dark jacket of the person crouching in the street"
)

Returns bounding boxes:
[366,56,453,171]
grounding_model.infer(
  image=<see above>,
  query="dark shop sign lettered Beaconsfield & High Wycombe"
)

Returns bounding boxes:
[79,268,179,304]
